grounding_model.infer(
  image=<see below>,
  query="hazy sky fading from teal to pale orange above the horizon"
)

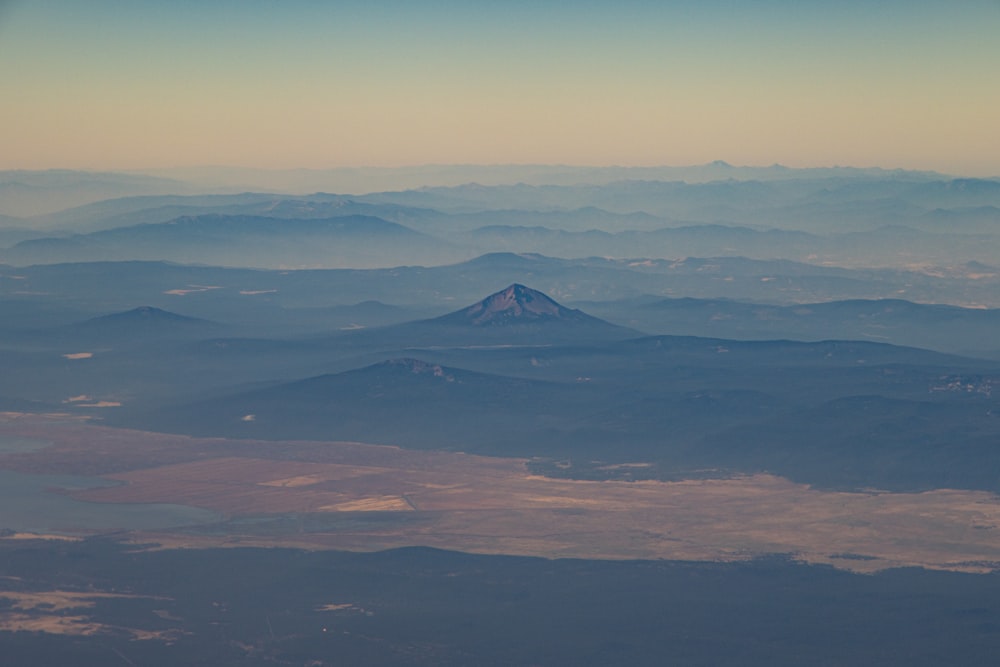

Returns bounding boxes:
[0,0,1000,175]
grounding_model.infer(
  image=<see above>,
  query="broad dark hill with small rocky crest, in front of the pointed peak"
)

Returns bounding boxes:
[143,359,592,456]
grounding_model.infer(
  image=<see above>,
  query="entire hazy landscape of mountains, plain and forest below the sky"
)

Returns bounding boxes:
[0,166,1000,665]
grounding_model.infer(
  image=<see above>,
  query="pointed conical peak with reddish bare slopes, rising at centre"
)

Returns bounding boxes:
[437,283,601,327]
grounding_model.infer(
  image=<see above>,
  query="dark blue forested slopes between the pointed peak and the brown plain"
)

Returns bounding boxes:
[125,337,1000,491]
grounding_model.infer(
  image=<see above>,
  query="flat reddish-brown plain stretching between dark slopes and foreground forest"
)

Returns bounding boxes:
[0,415,1000,571]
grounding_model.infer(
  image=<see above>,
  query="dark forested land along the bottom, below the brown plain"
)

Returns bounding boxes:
[0,540,1000,667]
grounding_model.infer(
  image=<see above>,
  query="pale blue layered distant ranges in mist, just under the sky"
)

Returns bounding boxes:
[0,170,1000,268]
